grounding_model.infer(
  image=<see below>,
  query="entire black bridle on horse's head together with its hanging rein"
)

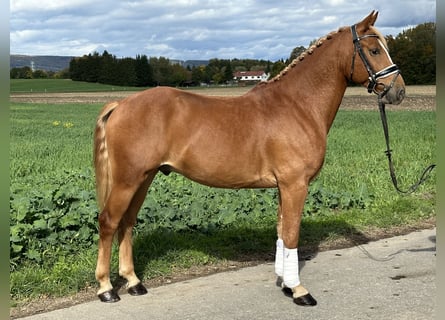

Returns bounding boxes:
[349,25,436,194]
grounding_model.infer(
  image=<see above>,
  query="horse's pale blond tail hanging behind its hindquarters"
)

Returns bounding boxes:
[93,102,119,211]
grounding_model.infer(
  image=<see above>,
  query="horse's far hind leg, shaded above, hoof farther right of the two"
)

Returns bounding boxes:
[118,171,156,295]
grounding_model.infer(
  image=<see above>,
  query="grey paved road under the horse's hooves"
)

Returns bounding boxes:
[17,229,436,320]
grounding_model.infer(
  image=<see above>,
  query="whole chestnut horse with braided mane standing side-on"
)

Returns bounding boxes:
[94,11,405,305]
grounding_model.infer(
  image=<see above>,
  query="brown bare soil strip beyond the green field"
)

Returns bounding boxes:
[10,86,436,110]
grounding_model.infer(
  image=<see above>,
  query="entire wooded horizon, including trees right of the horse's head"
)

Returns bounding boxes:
[10,22,436,87]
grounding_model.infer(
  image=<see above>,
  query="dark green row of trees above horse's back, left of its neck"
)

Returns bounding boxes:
[69,51,285,87]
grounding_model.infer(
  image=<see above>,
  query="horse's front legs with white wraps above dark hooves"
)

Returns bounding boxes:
[275,182,317,306]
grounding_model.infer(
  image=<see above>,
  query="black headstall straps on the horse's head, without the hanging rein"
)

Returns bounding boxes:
[350,25,400,97]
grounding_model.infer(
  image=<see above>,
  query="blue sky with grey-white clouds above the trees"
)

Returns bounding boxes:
[9,0,436,61]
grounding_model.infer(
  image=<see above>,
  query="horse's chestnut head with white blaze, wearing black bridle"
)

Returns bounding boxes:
[350,11,405,104]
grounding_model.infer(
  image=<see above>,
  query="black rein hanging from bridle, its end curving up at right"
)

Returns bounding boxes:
[378,92,436,194]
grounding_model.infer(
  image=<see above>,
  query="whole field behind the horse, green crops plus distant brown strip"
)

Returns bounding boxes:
[10,81,436,316]
